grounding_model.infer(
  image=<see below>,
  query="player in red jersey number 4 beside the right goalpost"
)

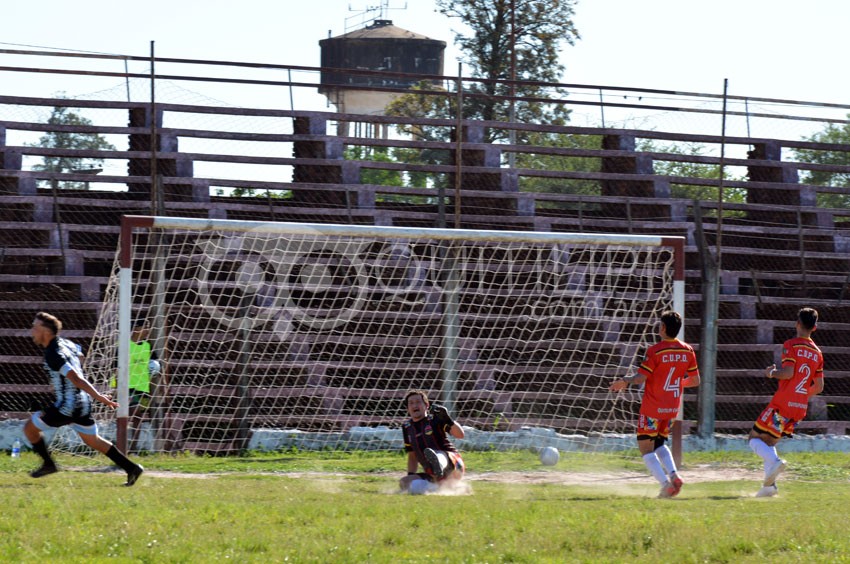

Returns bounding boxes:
[610,311,699,497]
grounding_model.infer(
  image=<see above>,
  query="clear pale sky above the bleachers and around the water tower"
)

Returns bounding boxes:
[0,0,850,109]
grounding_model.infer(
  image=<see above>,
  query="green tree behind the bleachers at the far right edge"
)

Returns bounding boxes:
[793,119,850,208]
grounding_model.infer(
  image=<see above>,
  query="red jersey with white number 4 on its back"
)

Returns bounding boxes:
[638,339,699,419]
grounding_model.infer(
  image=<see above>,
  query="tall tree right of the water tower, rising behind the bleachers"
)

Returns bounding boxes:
[368,0,582,196]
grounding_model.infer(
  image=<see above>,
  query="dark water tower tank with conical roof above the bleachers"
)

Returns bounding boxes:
[319,20,446,115]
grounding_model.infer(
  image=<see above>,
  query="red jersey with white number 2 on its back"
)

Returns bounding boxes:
[770,337,823,421]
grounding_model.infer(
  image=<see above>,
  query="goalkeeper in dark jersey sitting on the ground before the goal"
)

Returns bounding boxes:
[399,390,465,493]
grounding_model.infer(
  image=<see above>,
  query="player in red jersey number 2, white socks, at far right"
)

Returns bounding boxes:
[750,307,823,497]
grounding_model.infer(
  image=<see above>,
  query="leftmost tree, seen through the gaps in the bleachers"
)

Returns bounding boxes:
[29,101,115,190]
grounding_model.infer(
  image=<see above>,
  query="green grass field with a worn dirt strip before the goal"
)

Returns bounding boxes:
[0,452,850,562]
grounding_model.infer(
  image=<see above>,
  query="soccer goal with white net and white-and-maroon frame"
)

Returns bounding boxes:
[86,216,684,453]
